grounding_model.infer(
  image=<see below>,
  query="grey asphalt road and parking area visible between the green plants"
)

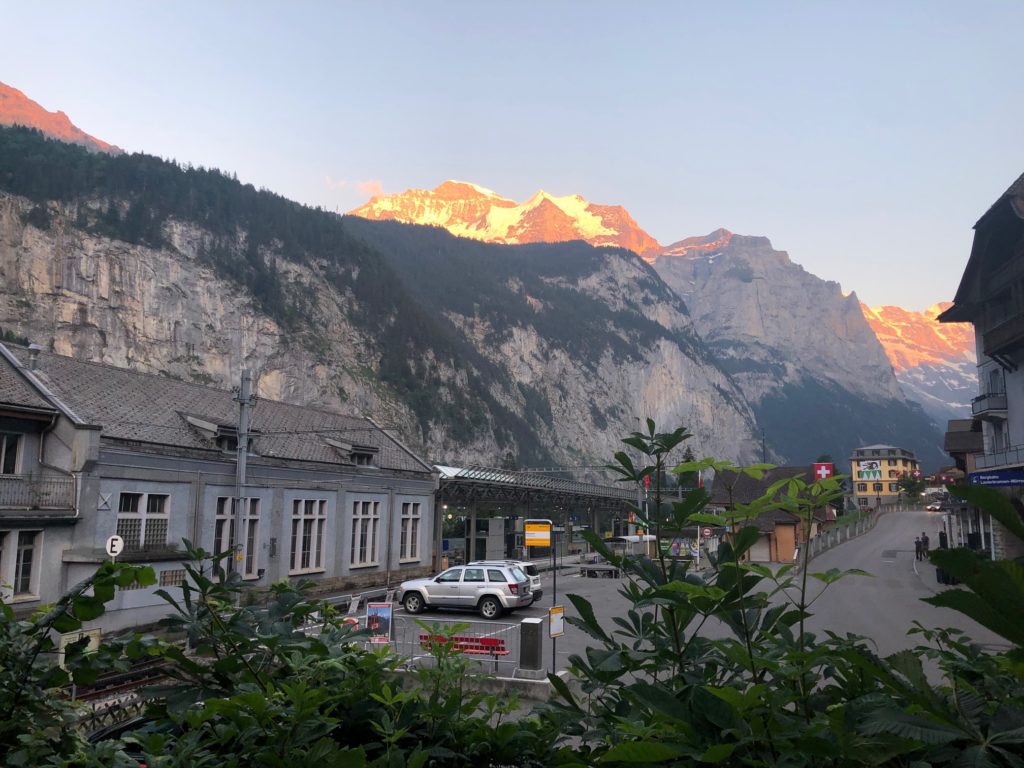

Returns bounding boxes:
[397,510,1005,670]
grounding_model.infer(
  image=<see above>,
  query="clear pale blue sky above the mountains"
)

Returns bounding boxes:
[0,0,1024,310]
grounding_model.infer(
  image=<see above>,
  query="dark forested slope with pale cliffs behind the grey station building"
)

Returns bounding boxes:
[0,128,755,465]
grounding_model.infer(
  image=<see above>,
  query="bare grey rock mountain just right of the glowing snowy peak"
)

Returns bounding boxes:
[654,229,938,462]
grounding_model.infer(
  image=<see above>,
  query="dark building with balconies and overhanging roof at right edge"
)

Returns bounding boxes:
[939,175,1024,558]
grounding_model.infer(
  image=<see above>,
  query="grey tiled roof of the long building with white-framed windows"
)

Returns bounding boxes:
[3,349,431,472]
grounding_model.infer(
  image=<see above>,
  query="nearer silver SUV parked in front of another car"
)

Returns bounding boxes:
[397,563,534,618]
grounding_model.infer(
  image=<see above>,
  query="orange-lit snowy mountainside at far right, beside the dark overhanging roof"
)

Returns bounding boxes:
[861,302,978,427]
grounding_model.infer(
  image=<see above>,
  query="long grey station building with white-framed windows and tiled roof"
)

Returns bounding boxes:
[0,345,439,631]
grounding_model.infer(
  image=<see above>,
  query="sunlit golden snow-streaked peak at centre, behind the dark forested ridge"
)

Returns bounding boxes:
[351,181,659,257]
